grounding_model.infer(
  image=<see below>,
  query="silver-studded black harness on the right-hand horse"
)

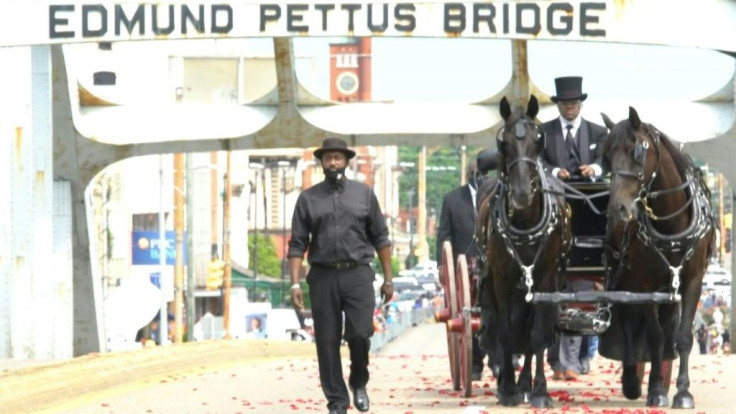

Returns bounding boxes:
[604,125,715,302]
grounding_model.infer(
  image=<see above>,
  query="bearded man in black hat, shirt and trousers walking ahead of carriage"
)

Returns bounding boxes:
[288,138,393,414]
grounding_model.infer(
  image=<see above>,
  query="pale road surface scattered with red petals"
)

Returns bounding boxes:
[0,324,736,414]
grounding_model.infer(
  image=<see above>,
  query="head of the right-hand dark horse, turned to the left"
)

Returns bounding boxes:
[601,107,659,224]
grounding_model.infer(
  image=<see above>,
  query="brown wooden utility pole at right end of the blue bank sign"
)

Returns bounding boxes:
[174,153,184,344]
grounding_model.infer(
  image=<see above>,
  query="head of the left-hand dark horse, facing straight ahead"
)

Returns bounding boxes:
[496,95,544,210]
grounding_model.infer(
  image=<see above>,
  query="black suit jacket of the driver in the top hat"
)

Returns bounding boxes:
[542,117,608,174]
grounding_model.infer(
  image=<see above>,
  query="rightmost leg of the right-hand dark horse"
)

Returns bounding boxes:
[672,286,699,408]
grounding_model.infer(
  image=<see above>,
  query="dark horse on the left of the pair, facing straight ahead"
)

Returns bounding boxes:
[476,95,570,408]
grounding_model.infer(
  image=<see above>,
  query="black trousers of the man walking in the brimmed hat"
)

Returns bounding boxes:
[307,265,376,409]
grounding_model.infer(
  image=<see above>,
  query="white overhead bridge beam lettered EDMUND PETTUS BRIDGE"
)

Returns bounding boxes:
[0,0,736,52]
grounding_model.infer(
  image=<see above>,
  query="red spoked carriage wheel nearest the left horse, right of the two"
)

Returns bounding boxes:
[455,254,473,398]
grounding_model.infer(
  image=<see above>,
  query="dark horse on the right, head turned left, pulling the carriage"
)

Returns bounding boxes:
[599,108,715,408]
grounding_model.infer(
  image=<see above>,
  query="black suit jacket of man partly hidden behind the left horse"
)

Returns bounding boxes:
[437,184,476,264]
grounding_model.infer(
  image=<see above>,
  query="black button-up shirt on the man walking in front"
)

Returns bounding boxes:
[288,179,391,265]
